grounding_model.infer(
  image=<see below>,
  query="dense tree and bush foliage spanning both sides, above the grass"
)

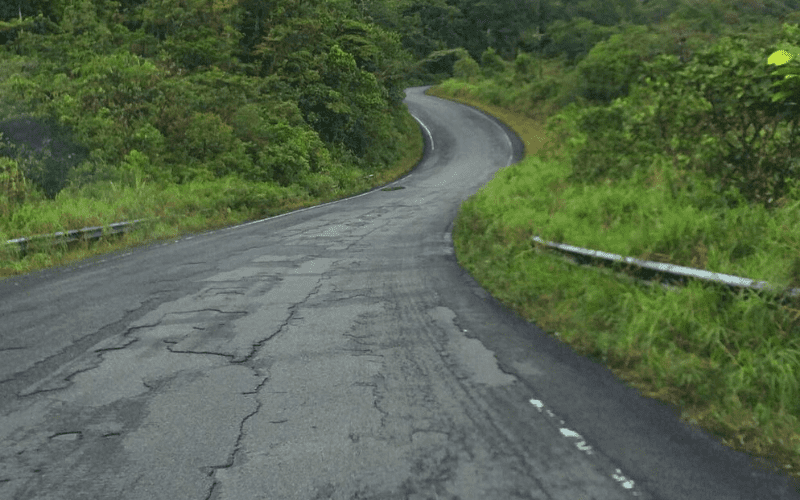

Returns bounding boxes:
[0,0,800,217]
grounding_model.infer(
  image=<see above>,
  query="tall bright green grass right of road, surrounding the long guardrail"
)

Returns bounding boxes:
[428,84,800,479]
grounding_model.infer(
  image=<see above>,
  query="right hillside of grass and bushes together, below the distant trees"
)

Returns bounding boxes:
[430,0,800,484]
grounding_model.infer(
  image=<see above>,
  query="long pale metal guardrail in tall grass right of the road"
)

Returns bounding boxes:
[532,236,800,297]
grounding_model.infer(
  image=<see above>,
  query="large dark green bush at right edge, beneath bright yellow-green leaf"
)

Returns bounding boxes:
[644,33,800,207]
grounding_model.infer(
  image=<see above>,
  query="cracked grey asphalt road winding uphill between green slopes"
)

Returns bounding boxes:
[0,88,800,500]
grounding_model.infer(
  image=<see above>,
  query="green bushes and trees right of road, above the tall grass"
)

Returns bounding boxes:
[404,0,800,211]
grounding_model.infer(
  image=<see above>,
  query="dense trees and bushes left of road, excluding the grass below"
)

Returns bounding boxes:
[0,0,418,207]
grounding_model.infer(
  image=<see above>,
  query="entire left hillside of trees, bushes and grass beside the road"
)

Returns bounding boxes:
[0,0,422,275]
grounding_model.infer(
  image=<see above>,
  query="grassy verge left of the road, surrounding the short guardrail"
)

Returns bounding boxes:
[0,109,424,279]
